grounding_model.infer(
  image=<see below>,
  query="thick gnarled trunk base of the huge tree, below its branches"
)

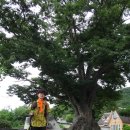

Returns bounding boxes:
[69,98,100,130]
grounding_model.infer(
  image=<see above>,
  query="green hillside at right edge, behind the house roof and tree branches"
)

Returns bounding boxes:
[117,87,130,108]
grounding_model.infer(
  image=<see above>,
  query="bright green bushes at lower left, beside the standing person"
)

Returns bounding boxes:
[0,106,29,128]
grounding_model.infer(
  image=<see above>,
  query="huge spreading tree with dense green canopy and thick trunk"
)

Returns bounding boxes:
[0,0,130,130]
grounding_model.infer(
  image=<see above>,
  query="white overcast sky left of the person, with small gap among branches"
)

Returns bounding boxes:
[0,67,39,110]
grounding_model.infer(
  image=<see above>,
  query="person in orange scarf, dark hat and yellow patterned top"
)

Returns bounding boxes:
[30,89,49,130]
